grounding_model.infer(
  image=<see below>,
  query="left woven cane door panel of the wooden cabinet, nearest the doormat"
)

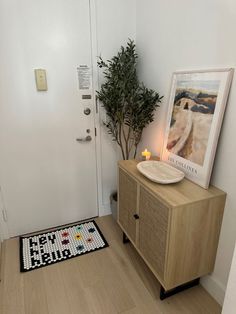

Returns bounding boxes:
[118,169,137,242]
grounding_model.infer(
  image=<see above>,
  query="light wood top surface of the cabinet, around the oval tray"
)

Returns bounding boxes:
[118,160,226,206]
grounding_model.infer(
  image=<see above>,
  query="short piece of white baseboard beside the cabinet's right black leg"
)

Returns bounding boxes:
[201,275,226,305]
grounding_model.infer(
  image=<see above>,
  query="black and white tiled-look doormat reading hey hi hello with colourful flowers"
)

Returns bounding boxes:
[20,220,108,272]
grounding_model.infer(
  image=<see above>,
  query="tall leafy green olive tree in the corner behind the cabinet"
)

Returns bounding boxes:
[97,40,162,218]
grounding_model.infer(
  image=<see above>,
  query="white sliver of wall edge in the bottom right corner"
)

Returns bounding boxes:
[222,246,236,314]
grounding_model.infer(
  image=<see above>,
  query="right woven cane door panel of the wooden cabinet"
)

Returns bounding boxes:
[139,187,169,279]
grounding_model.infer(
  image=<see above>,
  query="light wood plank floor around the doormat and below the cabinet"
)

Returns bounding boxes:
[0,216,221,314]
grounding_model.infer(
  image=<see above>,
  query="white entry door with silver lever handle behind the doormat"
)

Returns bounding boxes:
[0,0,98,236]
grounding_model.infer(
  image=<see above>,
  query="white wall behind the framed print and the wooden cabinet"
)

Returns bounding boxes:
[136,0,236,304]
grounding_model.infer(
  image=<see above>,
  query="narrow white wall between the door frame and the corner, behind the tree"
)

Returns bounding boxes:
[97,0,136,214]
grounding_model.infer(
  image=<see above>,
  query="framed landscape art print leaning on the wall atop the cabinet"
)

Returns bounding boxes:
[161,68,233,189]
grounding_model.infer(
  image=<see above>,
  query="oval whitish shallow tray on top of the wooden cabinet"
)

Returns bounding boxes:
[137,160,184,184]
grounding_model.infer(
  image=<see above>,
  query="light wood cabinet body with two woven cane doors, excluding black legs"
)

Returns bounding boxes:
[118,160,226,290]
